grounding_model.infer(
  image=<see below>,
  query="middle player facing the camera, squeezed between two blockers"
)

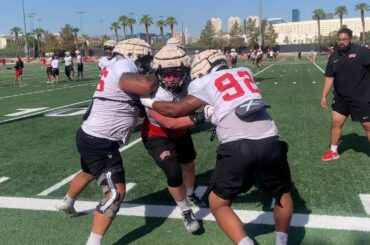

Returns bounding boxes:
[141,44,205,233]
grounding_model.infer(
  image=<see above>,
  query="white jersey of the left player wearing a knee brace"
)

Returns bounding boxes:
[82,56,139,144]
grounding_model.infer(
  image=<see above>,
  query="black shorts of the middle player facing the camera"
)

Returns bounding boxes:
[143,132,197,167]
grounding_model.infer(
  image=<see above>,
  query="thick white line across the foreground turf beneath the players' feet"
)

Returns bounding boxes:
[0,197,370,232]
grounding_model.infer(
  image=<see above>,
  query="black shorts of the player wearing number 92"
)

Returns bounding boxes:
[209,136,292,204]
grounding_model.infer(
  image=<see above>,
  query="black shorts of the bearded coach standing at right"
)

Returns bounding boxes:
[331,95,370,122]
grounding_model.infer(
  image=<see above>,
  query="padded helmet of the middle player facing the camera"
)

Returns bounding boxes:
[153,45,190,92]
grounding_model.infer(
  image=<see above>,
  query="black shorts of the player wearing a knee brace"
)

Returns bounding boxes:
[76,128,125,183]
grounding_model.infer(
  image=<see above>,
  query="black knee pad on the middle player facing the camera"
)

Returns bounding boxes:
[161,155,183,187]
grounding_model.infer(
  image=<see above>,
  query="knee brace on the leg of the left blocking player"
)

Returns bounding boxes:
[96,169,122,218]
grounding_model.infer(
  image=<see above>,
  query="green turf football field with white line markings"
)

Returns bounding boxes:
[0,57,370,245]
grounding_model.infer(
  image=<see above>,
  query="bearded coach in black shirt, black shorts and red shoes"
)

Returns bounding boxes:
[321,28,370,161]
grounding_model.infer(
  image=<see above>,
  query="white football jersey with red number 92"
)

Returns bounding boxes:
[188,67,277,143]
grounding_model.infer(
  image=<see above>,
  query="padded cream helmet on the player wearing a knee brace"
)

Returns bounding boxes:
[113,38,153,73]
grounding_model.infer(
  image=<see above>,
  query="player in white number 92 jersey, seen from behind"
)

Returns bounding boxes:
[141,50,293,245]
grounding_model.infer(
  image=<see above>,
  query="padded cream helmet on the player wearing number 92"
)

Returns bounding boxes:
[191,49,228,79]
